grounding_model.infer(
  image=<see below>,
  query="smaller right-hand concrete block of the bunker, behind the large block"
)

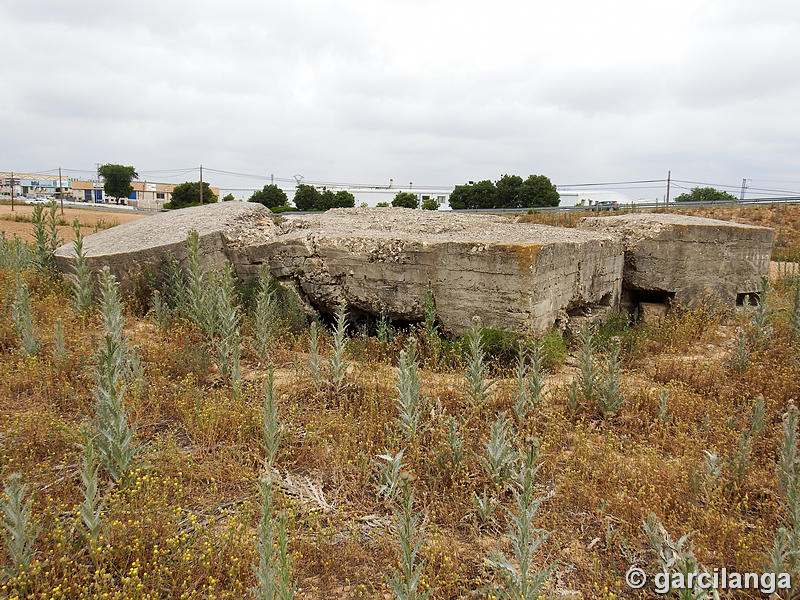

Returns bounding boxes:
[578,213,774,306]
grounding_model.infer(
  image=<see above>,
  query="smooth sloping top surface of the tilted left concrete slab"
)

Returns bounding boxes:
[56,202,274,258]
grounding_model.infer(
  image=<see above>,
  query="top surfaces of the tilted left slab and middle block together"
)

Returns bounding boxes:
[56,202,616,259]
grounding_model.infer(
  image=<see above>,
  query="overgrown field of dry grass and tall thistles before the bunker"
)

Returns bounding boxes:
[0,204,800,599]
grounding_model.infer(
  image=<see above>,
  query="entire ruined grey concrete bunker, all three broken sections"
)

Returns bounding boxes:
[51,202,773,335]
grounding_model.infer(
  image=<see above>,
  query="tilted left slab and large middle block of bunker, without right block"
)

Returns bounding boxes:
[57,203,623,334]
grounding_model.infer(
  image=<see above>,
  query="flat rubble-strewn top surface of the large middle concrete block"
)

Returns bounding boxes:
[278,208,613,244]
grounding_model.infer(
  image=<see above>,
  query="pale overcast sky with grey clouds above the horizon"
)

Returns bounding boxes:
[0,0,800,197]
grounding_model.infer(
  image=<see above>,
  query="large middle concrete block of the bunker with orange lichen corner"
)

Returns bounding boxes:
[236,209,622,334]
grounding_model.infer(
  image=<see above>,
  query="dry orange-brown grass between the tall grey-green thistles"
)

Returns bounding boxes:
[0,210,800,599]
